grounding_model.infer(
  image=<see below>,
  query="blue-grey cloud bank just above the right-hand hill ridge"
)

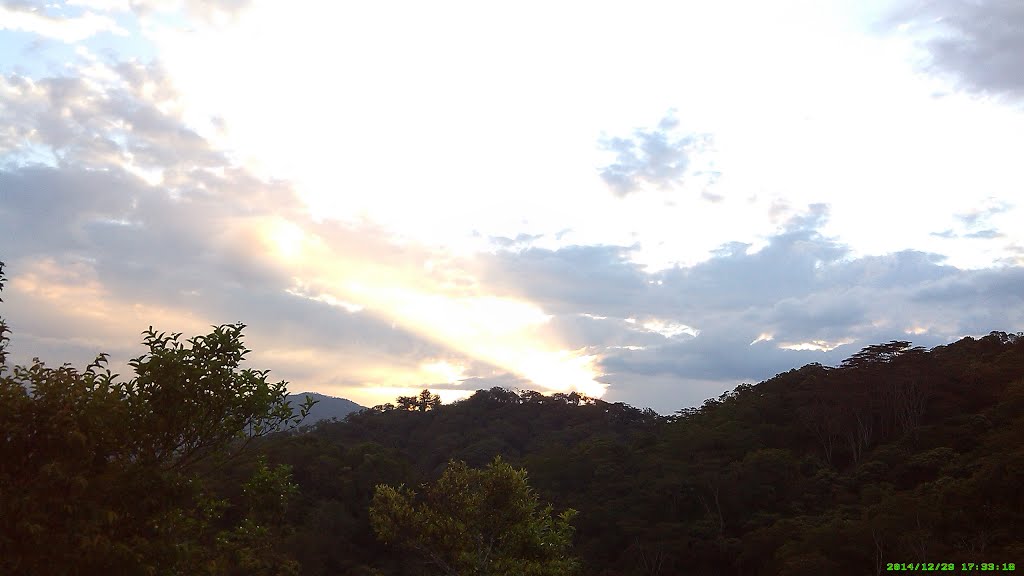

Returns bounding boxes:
[481,205,1024,412]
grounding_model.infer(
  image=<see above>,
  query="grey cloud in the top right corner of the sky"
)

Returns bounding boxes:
[885,0,1024,98]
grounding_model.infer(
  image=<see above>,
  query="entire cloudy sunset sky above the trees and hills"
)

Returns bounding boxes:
[0,0,1024,414]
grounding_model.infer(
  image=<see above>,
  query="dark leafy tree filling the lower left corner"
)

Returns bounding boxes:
[0,261,313,575]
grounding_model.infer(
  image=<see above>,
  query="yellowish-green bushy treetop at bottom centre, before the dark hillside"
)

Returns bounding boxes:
[370,457,577,576]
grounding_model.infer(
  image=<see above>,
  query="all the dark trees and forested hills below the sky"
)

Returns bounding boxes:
[0,261,1024,576]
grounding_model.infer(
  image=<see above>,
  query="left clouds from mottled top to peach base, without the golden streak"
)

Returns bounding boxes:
[0,59,487,403]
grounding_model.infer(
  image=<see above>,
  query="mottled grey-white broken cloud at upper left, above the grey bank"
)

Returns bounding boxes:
[0,63,228,180]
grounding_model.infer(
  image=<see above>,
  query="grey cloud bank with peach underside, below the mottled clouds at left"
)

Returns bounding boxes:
[0,158,468,394]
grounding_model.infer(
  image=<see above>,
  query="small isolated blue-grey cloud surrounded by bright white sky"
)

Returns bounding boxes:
[600,116,710,196]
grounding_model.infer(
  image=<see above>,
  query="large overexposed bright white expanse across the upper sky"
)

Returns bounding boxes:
[128,1,1024,272]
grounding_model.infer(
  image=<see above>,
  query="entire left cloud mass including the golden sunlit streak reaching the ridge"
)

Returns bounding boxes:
[0,54,603,402]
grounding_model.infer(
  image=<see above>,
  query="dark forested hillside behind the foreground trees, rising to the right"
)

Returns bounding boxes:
[245,332,1024,575]
